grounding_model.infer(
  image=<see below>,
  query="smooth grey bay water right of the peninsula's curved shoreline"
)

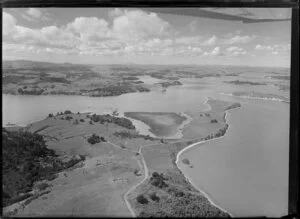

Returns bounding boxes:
[179,101,289,217]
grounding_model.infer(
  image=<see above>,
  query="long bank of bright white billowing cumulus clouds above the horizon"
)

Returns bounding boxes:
[3,9,258,57]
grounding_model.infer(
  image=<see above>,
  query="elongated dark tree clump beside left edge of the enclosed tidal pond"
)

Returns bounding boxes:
[90,114,135,129]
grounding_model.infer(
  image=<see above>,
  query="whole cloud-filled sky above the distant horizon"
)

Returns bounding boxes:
[2,8,291,67]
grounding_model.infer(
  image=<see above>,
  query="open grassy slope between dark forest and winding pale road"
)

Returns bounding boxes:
[4,114,158,216]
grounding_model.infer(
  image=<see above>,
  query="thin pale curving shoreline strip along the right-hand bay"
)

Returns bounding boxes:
[175,106,241,218]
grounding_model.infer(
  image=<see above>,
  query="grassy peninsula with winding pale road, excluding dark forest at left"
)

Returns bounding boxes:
[3,100,240,217]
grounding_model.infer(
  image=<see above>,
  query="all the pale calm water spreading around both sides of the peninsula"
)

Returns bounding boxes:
[2,75,289,216]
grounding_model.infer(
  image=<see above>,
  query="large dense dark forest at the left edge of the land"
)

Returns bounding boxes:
[2,129,84,206]
